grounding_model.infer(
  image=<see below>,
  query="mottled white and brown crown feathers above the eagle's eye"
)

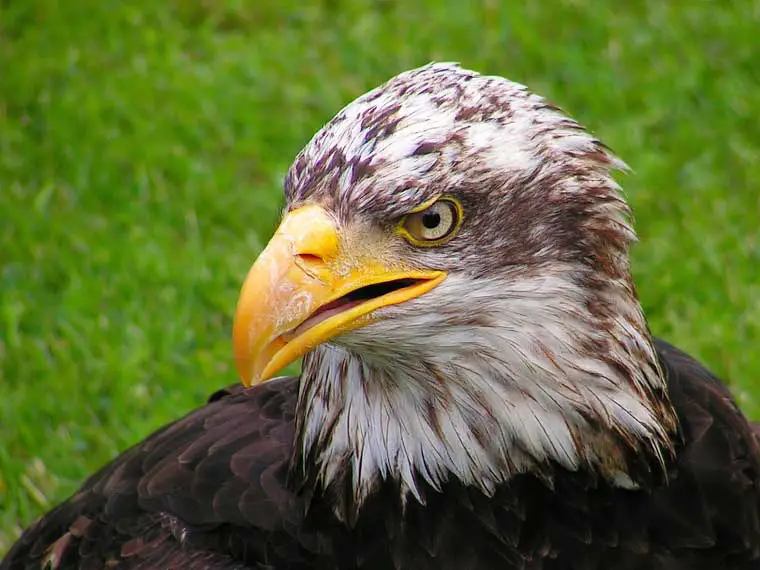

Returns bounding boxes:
[285,64,635,278]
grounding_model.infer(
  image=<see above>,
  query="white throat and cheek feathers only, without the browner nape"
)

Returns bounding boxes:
[302,268,665,500]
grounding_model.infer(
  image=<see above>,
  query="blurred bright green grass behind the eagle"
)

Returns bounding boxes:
[0,0,760,554]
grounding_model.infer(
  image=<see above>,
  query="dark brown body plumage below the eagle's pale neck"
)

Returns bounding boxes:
[0,342,760,570]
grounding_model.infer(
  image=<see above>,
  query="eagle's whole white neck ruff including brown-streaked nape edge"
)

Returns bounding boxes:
[293,268,676,508]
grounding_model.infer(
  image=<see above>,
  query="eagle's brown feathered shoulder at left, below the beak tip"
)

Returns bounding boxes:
[0,378,330,570]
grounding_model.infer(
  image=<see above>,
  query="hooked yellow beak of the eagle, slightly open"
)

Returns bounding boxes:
[233,205,446,386]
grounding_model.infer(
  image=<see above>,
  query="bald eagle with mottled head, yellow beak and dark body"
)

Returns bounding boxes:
[0,64,760,570]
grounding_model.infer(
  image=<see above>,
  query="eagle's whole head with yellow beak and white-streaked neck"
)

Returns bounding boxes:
[234,64,675,505]
